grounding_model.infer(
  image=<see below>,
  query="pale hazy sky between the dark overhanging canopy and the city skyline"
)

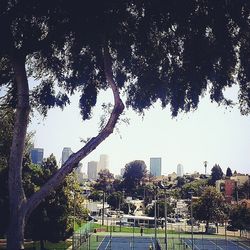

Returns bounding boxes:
[29,87,250,177]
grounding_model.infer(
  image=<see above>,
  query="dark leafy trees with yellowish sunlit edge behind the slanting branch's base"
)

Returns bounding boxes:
[24,155,87,242]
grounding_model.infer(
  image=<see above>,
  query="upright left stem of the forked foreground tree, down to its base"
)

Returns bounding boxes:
[7,55,30,250]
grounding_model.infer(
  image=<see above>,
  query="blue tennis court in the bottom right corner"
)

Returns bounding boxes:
[183,239,250,250]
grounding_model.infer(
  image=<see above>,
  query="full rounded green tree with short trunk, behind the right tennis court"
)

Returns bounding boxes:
[193,186,228,229]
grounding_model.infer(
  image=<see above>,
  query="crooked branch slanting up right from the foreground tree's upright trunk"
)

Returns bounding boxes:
[26,43,124,219]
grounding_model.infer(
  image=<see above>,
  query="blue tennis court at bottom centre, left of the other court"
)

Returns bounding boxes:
[98,236,157,250]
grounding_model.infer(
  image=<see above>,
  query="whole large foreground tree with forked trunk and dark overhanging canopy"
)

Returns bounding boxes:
[0,0,250,249]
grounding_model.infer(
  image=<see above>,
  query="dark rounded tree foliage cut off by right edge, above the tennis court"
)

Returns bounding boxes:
[229,204,250,231]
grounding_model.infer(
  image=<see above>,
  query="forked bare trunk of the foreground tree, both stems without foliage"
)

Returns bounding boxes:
[7,47,124,250]
